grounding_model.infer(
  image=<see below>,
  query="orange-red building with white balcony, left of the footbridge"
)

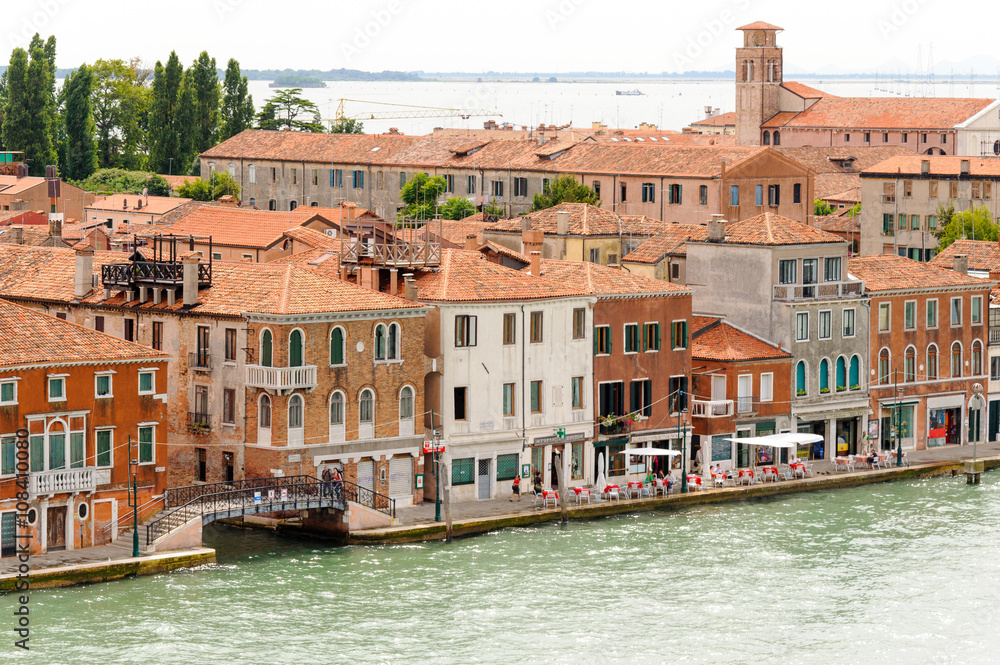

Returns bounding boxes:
[0,301,168,557]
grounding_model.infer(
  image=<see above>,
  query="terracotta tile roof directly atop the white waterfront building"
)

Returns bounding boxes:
[417,249,585,302]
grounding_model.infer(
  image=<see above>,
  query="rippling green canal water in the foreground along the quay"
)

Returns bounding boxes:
[7,473,1000,665]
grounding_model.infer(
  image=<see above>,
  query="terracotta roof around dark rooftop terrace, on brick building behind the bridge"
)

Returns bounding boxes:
[0,245,420,316]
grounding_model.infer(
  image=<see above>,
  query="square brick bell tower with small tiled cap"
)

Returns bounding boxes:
[736,21,782,145]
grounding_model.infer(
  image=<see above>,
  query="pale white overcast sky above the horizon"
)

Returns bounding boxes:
[9,0,998,76]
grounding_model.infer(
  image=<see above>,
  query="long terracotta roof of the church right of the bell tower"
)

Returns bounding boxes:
[764,97,993,130]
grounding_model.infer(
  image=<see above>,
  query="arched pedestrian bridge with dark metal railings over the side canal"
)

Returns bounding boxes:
[140,476,396,550]
